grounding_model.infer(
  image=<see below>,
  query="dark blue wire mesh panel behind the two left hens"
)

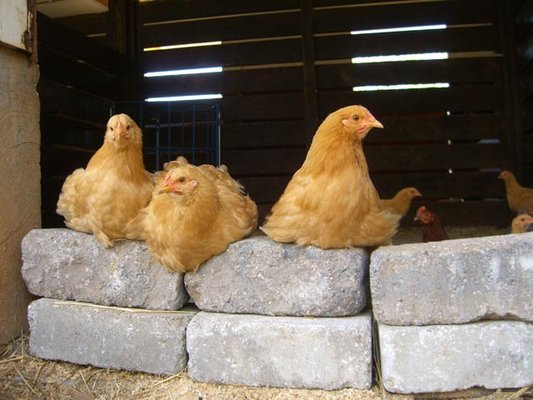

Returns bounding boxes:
[110,101,220,171]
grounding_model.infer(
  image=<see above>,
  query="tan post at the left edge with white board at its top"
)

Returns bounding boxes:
[0,0,41,344]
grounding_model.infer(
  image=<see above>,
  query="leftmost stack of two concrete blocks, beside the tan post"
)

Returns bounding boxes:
[22,229,196,375]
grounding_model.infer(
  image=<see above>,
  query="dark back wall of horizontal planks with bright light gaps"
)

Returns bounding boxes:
[138,0,512,226]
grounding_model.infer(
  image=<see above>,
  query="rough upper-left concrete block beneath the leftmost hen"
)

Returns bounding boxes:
[22,229,188,310]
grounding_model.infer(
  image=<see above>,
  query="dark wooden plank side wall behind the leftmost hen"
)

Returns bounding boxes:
[37,14,123,227]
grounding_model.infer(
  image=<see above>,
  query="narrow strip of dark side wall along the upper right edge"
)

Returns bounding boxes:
[514,0,533,187]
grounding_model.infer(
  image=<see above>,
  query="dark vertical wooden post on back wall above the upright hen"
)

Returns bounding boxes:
[301,0,318,148]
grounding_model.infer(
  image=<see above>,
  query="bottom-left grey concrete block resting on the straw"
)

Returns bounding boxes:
[28,299,196,375]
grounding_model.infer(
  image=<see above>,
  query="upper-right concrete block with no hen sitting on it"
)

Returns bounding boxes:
[370,233,533,325]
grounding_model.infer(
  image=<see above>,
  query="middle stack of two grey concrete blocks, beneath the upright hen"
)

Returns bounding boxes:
[185,236,372,390]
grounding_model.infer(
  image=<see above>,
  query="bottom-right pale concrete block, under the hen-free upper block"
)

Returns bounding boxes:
[378,321,533,393]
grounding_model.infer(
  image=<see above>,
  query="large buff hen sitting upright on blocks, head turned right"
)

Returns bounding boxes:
[261,106,398,249]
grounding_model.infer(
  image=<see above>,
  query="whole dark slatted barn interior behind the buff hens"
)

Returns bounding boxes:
[37,0,533,228]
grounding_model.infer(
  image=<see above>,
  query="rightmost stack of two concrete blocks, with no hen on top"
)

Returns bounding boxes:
[370,233,533,393]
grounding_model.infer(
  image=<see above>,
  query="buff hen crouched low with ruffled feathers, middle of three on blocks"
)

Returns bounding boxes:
[128,158,257,272]
